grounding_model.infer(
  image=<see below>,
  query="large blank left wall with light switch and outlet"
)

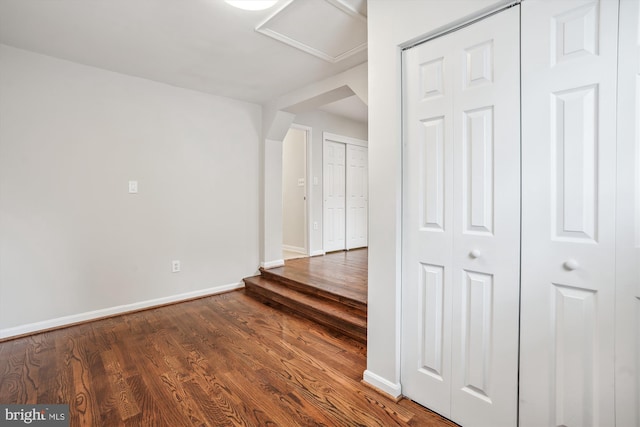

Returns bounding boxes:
[0,45,261,337]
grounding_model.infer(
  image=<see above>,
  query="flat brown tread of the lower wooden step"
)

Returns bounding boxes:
[244,276,367,330]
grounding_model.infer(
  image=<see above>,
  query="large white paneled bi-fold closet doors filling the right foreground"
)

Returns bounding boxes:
[402,0,640,427]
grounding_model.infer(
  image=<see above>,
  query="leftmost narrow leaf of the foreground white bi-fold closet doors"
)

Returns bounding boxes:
[401,24,452,417]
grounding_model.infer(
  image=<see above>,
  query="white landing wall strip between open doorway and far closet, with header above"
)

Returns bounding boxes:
[294,110,368,254]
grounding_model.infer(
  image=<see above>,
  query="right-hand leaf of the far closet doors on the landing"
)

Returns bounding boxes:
[346,144,369,249]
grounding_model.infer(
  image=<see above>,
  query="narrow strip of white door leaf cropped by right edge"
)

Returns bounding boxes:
[615,0,640,426]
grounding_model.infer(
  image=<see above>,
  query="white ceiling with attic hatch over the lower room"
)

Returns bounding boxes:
[0,0,367,110]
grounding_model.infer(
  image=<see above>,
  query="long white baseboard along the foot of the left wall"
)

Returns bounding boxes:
[0,282,244,339]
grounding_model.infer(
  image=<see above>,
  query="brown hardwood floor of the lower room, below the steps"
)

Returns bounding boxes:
[0,291,455,427]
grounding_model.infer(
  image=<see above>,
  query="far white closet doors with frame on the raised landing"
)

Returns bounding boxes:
[323,133,369,252]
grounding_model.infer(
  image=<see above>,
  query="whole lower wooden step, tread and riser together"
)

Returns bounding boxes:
[244,272,367,343]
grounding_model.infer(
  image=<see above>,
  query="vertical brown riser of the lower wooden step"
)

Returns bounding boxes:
[245,282,367,344]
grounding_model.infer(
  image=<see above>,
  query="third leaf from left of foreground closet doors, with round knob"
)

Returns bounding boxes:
[520,0,618,427]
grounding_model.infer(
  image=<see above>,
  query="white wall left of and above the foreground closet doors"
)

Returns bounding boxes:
[364,0,509,395]
